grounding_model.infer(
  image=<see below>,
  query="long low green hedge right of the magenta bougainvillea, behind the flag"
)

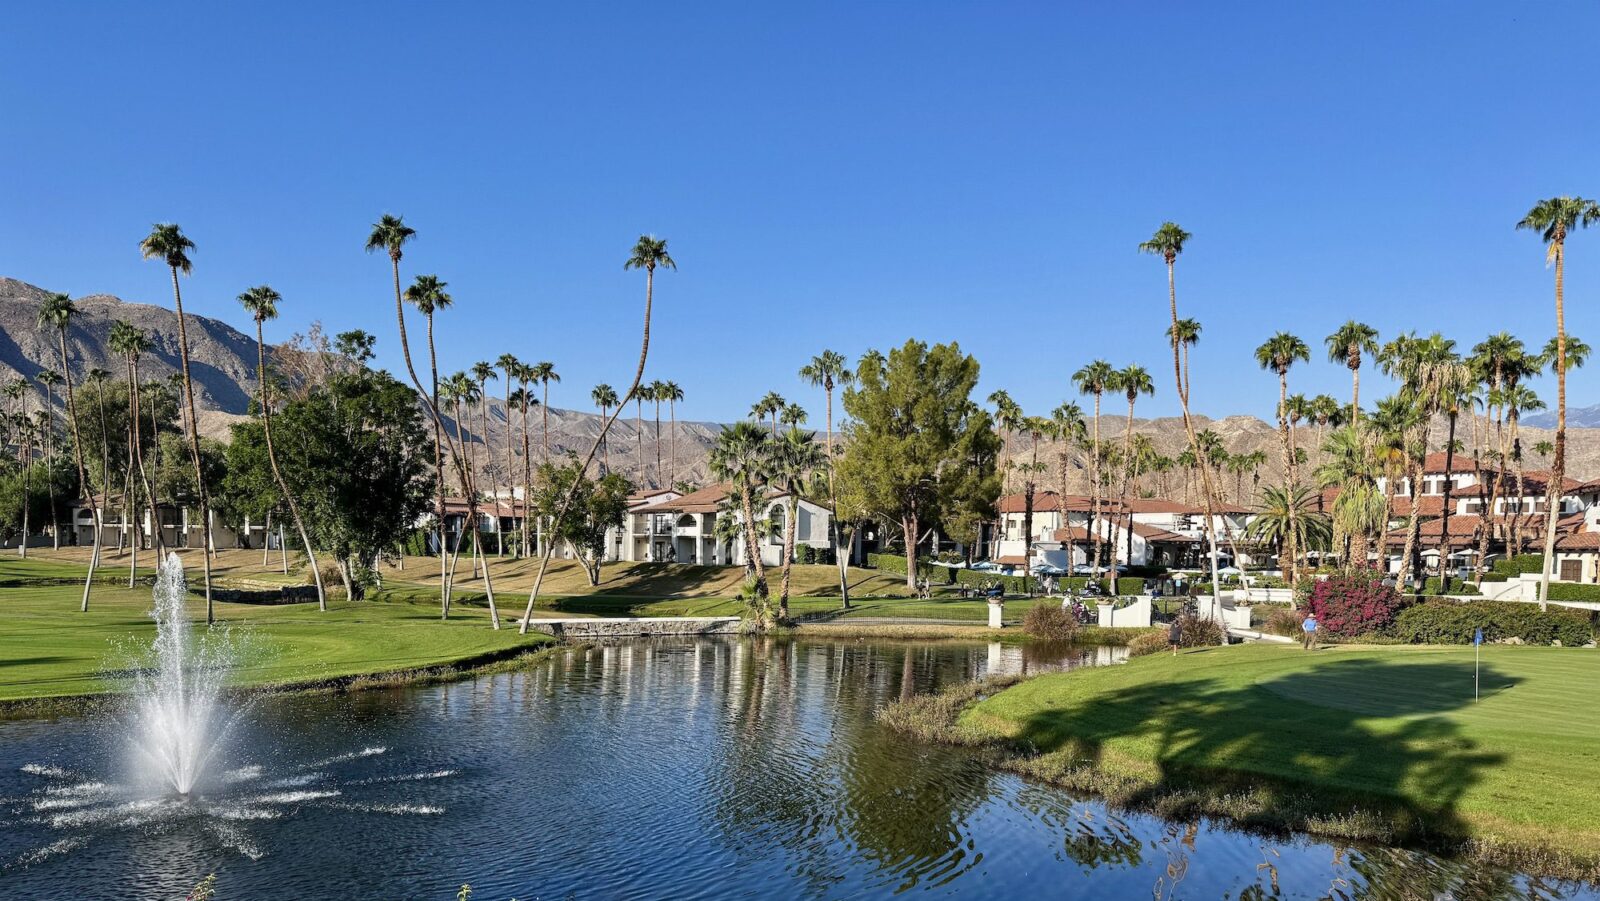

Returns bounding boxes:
[1392,600,1594,647]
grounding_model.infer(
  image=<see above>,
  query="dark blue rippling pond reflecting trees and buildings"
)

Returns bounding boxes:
[0,639,1597,901]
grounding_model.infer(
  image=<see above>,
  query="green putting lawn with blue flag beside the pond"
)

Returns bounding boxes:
[958,645,1600,861]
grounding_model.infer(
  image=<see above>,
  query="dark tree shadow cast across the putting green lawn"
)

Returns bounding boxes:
[1014,659,1507,848]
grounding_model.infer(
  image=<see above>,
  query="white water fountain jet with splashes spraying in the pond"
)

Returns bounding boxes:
[0,554,456,875]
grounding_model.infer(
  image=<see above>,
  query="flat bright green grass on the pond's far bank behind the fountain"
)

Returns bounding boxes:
[0,576,549,703]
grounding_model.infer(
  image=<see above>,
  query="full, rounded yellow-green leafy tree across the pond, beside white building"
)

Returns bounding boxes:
[842,341,1000,589]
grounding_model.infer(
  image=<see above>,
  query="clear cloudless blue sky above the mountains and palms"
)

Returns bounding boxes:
[0,2,1600,424]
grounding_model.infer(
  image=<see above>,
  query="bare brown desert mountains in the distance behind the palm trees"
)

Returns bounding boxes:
[0,277,1600,491]
